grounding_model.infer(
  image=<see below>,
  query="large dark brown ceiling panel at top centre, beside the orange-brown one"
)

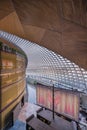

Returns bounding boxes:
[13,0,61,31]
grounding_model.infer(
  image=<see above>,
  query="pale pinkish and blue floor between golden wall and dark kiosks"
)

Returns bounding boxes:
[9,103,40,130]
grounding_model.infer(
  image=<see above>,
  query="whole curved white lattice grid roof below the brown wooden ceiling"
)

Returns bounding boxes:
[0,31,87,93]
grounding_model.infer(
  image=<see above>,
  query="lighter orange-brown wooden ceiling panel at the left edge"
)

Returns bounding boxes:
[0,11,24,37]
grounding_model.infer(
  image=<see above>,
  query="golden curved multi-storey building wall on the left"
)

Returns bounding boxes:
[0,39,26,130]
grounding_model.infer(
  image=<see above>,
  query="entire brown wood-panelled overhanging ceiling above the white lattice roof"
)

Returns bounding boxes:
[0,0,87,70]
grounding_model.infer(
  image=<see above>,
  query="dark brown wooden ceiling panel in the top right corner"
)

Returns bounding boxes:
[62,0,87,27]
